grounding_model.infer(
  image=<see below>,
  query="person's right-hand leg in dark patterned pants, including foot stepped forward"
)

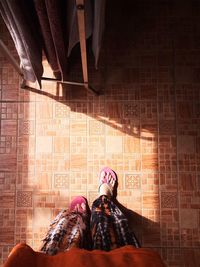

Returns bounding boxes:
[90,170,139,251]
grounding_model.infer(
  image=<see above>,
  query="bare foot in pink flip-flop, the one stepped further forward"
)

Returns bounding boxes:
[99,169,116,198]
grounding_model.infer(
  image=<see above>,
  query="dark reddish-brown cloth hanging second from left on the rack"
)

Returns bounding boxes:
[34,0,68,80]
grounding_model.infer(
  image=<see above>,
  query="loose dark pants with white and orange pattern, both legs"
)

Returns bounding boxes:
[40,196,139,255]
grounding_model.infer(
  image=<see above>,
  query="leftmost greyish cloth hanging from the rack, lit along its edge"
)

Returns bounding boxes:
[0,0,43,86]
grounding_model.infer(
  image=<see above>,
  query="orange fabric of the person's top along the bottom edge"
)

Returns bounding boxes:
[4,244,165,267]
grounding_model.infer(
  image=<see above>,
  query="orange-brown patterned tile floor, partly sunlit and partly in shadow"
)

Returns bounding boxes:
[0,0,200,267]
